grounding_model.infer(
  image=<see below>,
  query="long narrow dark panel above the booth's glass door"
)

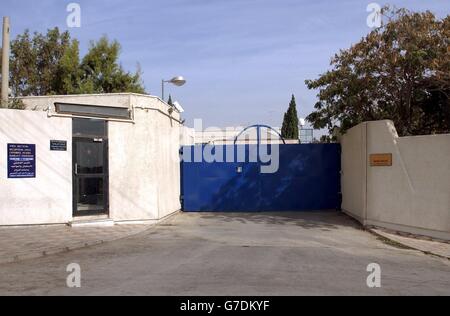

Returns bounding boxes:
[55,103,131,120]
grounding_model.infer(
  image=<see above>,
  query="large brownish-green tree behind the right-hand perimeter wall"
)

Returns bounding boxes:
[306,7,450,136]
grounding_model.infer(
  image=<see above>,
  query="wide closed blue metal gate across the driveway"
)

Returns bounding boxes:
[181,144,341,212]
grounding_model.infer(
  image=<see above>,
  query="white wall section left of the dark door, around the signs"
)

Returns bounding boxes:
[0,109,72,225]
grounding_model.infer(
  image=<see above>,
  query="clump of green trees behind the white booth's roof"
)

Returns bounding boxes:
[2,28,145,97]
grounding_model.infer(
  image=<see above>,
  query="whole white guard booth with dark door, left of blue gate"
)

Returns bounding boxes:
[0,93,182,225]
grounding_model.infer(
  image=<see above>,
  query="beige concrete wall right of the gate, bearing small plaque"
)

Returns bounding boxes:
[342,120,450,240]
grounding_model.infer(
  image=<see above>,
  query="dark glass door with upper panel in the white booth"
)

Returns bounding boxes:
[72,118,109,216]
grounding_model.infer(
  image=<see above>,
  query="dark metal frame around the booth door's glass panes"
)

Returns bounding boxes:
[72,126,110,217]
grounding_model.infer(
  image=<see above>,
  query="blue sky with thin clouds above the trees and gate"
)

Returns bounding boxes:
[1,0,450,131]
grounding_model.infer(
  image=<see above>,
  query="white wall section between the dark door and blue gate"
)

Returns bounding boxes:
[109,109,181,221]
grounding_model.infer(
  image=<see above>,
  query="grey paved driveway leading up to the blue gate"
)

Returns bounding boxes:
[0,212,450,295]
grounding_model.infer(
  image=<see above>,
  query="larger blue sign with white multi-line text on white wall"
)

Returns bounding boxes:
[8,144,36,179]
